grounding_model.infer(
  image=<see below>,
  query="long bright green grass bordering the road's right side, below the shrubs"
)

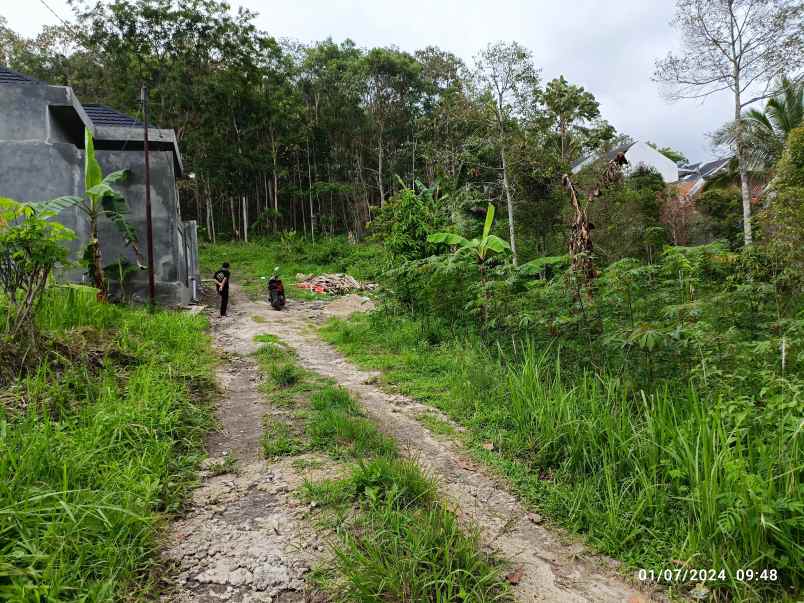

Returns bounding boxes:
[323,313,804,601]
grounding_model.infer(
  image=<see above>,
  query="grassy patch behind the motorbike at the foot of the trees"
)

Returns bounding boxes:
[199,237,382,299]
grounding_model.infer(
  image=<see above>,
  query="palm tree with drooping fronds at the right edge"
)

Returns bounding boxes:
[714,77,804,171]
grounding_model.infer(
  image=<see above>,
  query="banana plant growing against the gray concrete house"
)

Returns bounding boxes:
[34,129,144,299]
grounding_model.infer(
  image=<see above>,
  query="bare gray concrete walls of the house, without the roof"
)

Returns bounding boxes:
[0,84,191,304]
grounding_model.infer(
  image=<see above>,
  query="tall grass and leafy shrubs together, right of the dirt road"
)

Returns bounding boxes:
[325,232,804,600]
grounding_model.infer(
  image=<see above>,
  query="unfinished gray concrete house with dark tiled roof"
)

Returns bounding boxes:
[0,66,200,305]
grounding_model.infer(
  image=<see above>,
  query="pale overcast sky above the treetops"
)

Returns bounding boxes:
[0,0,732,161]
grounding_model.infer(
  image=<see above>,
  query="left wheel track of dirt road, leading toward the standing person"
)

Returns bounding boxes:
[162,291,324,603]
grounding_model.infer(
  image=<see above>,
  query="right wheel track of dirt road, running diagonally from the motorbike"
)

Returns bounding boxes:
[243,288,663,603]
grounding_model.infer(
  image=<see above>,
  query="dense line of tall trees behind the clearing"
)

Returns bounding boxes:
[0,0,615,248]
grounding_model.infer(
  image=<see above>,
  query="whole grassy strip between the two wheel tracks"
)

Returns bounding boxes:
[257,341,509,601]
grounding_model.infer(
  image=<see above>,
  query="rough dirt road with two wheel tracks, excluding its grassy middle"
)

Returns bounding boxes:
[165,287,650,603]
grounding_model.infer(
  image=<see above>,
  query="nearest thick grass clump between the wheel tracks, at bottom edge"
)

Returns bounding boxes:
[304,456,511,601]
